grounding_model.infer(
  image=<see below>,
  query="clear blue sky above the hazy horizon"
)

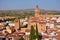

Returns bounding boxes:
[0,0,60,10]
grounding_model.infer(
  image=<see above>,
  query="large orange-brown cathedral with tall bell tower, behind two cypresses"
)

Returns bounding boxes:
[28,5,53,33]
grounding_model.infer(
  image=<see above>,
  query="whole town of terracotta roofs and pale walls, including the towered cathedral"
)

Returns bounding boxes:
[0,5,60,40]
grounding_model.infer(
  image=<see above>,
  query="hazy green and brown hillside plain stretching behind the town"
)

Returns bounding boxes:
[0,9,60,18]
